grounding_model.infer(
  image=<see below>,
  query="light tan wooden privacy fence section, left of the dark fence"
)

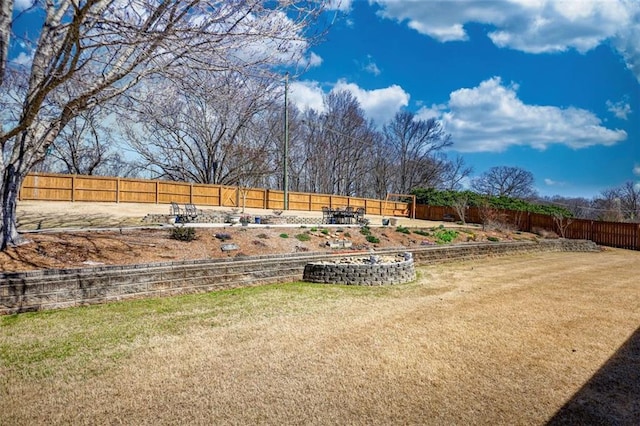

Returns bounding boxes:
[19,173,410,216]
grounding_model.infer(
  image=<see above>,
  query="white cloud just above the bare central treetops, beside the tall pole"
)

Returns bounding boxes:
[290,80,409,126]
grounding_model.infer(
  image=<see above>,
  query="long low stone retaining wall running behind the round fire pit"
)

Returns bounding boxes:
[0,240,598,314]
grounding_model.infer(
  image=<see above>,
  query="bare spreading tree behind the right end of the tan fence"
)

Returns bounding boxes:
[383,111,452,194]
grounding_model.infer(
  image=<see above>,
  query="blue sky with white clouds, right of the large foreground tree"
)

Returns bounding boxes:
[291,0,640,198]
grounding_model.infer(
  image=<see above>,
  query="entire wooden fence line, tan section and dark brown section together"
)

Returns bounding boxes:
[20,174,640,250]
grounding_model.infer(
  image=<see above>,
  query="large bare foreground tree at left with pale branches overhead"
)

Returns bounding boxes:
[0,0,322,249]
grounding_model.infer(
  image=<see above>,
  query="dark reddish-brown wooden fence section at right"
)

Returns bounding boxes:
[416,204,640,250]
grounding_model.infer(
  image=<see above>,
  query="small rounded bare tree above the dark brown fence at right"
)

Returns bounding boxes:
[471,166,535,198]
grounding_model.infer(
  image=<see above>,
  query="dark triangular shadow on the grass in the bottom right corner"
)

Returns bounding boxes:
[547,328,640,426]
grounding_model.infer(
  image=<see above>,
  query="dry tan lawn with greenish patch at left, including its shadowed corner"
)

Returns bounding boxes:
[0,250,640,425]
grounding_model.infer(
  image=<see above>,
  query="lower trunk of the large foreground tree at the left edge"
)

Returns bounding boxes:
[0,164,26,250]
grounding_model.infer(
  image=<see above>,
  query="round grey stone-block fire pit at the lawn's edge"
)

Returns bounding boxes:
[302,253,416,285]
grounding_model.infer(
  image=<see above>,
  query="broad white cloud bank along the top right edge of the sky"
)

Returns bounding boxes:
[371,0,640,81]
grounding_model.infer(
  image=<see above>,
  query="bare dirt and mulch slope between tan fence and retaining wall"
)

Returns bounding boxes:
[0,202,536,272]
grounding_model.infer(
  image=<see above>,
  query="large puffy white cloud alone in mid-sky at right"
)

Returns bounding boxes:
[432,77,627,152]
